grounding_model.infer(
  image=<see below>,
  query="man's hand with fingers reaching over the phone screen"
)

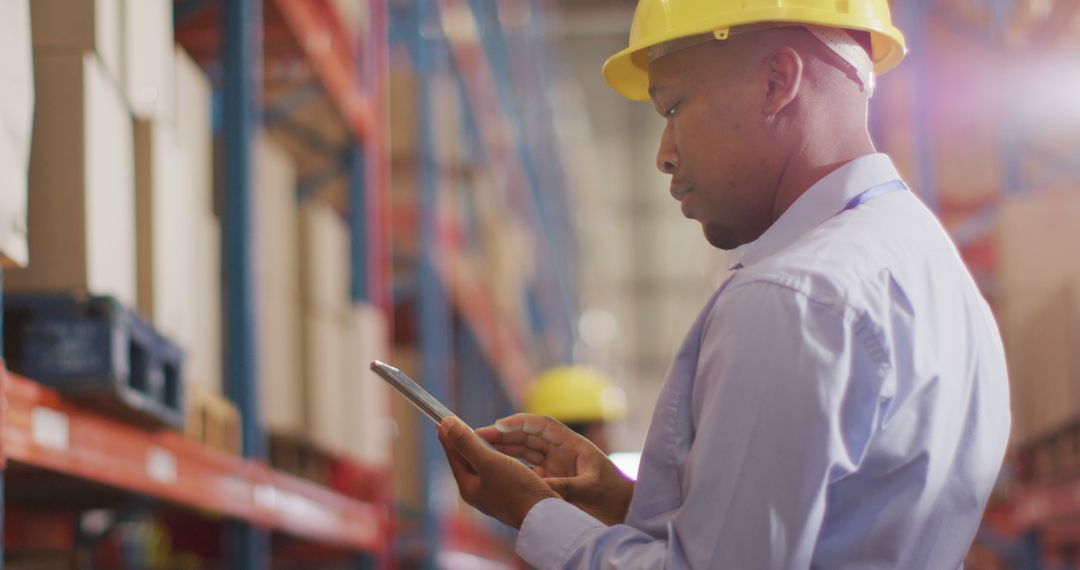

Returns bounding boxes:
[476,413,634,525]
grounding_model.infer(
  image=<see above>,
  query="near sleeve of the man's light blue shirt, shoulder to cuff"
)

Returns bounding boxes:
[518,281,881,569]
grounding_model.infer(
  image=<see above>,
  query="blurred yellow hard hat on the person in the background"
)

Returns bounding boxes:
[525,366,626,423]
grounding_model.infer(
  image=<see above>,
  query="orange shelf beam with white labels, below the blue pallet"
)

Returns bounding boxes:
[0,369,389,551]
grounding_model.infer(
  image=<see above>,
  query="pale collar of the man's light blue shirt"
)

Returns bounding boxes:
[731,152,900,270]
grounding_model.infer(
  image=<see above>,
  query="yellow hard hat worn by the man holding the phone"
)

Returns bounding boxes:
[604,0,906,100]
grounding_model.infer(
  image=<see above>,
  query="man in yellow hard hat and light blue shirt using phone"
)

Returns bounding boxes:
[440,0,1010,570]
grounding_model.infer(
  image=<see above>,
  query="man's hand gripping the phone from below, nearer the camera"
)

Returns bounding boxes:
[438,417,558,528]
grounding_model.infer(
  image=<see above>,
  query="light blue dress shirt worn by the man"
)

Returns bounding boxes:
[517,154,1010,570]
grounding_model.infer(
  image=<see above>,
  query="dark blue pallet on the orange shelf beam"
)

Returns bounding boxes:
[3,294,185,429]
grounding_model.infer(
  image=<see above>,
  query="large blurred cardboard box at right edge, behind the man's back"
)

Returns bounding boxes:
[997,188,1080,443]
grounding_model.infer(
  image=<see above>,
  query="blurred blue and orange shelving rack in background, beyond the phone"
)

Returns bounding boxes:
[390,0,579,567]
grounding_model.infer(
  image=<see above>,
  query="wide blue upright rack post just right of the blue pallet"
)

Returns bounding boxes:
[221,0,270,570]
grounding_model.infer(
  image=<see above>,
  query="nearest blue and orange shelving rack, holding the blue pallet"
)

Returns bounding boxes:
[0,0,392,569]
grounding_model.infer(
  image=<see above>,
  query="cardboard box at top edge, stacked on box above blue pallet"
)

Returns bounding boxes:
[30,0,122,84]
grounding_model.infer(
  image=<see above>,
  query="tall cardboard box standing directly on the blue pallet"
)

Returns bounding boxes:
[5,53,136,307]
